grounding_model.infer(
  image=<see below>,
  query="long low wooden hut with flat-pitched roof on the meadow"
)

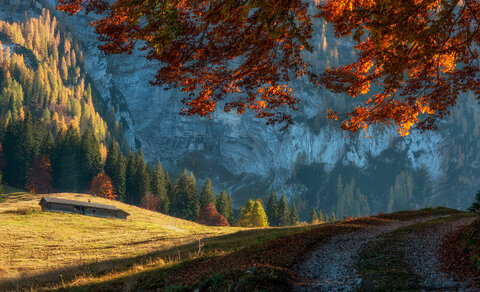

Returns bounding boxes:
[39,197,130,219]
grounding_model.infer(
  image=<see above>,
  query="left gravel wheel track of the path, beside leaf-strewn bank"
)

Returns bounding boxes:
[293,217,432,291]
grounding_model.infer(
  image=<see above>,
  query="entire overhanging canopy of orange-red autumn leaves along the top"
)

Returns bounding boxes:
[58,0,480,135]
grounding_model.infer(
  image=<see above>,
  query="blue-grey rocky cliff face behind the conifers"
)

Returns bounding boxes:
[8,0,478,215]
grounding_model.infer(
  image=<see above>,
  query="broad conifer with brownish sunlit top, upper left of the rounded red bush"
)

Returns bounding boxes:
[170,170,199,221]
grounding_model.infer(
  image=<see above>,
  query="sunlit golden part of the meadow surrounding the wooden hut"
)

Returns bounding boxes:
[0,187,241,290]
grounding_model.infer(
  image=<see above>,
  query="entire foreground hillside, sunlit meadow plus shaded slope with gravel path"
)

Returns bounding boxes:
[0,187,478,291]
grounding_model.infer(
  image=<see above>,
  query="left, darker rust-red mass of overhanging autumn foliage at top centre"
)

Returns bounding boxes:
[57,0,312,130]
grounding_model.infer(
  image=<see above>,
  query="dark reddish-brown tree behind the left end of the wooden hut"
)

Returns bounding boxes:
[25,155,53,194]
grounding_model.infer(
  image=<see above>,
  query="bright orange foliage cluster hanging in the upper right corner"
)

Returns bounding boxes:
[317,0,480,135]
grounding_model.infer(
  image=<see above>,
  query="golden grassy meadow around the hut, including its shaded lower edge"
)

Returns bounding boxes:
[0,187,314,290]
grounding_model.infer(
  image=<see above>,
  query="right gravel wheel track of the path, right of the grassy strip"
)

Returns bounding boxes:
[402,218,478,291]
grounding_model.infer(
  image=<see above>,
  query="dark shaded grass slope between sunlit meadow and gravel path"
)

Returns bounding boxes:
[0,208,464,291]
